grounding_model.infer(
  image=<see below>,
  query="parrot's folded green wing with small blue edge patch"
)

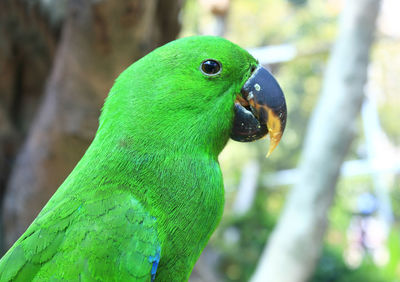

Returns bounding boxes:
[0,189,160,281]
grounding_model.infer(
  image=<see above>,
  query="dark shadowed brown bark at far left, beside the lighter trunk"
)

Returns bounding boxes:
[0,0,59,196]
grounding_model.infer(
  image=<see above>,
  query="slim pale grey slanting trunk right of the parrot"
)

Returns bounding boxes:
[252,0,380,282]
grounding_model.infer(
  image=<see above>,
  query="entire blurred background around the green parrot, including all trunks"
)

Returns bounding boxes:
[0,0,400,282]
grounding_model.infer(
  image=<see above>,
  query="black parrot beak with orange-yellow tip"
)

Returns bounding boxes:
[231,66,287,157]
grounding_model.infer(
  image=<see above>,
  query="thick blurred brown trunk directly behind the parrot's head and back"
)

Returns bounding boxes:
[3,0,181,247]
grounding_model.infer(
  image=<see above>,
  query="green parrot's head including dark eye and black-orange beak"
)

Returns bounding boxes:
[100,36,286,154]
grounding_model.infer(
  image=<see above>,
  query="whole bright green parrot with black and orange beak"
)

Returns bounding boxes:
[0,36,286,281]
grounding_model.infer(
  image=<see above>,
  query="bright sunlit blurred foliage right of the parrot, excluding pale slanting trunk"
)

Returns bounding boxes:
[181,0,400,281]
